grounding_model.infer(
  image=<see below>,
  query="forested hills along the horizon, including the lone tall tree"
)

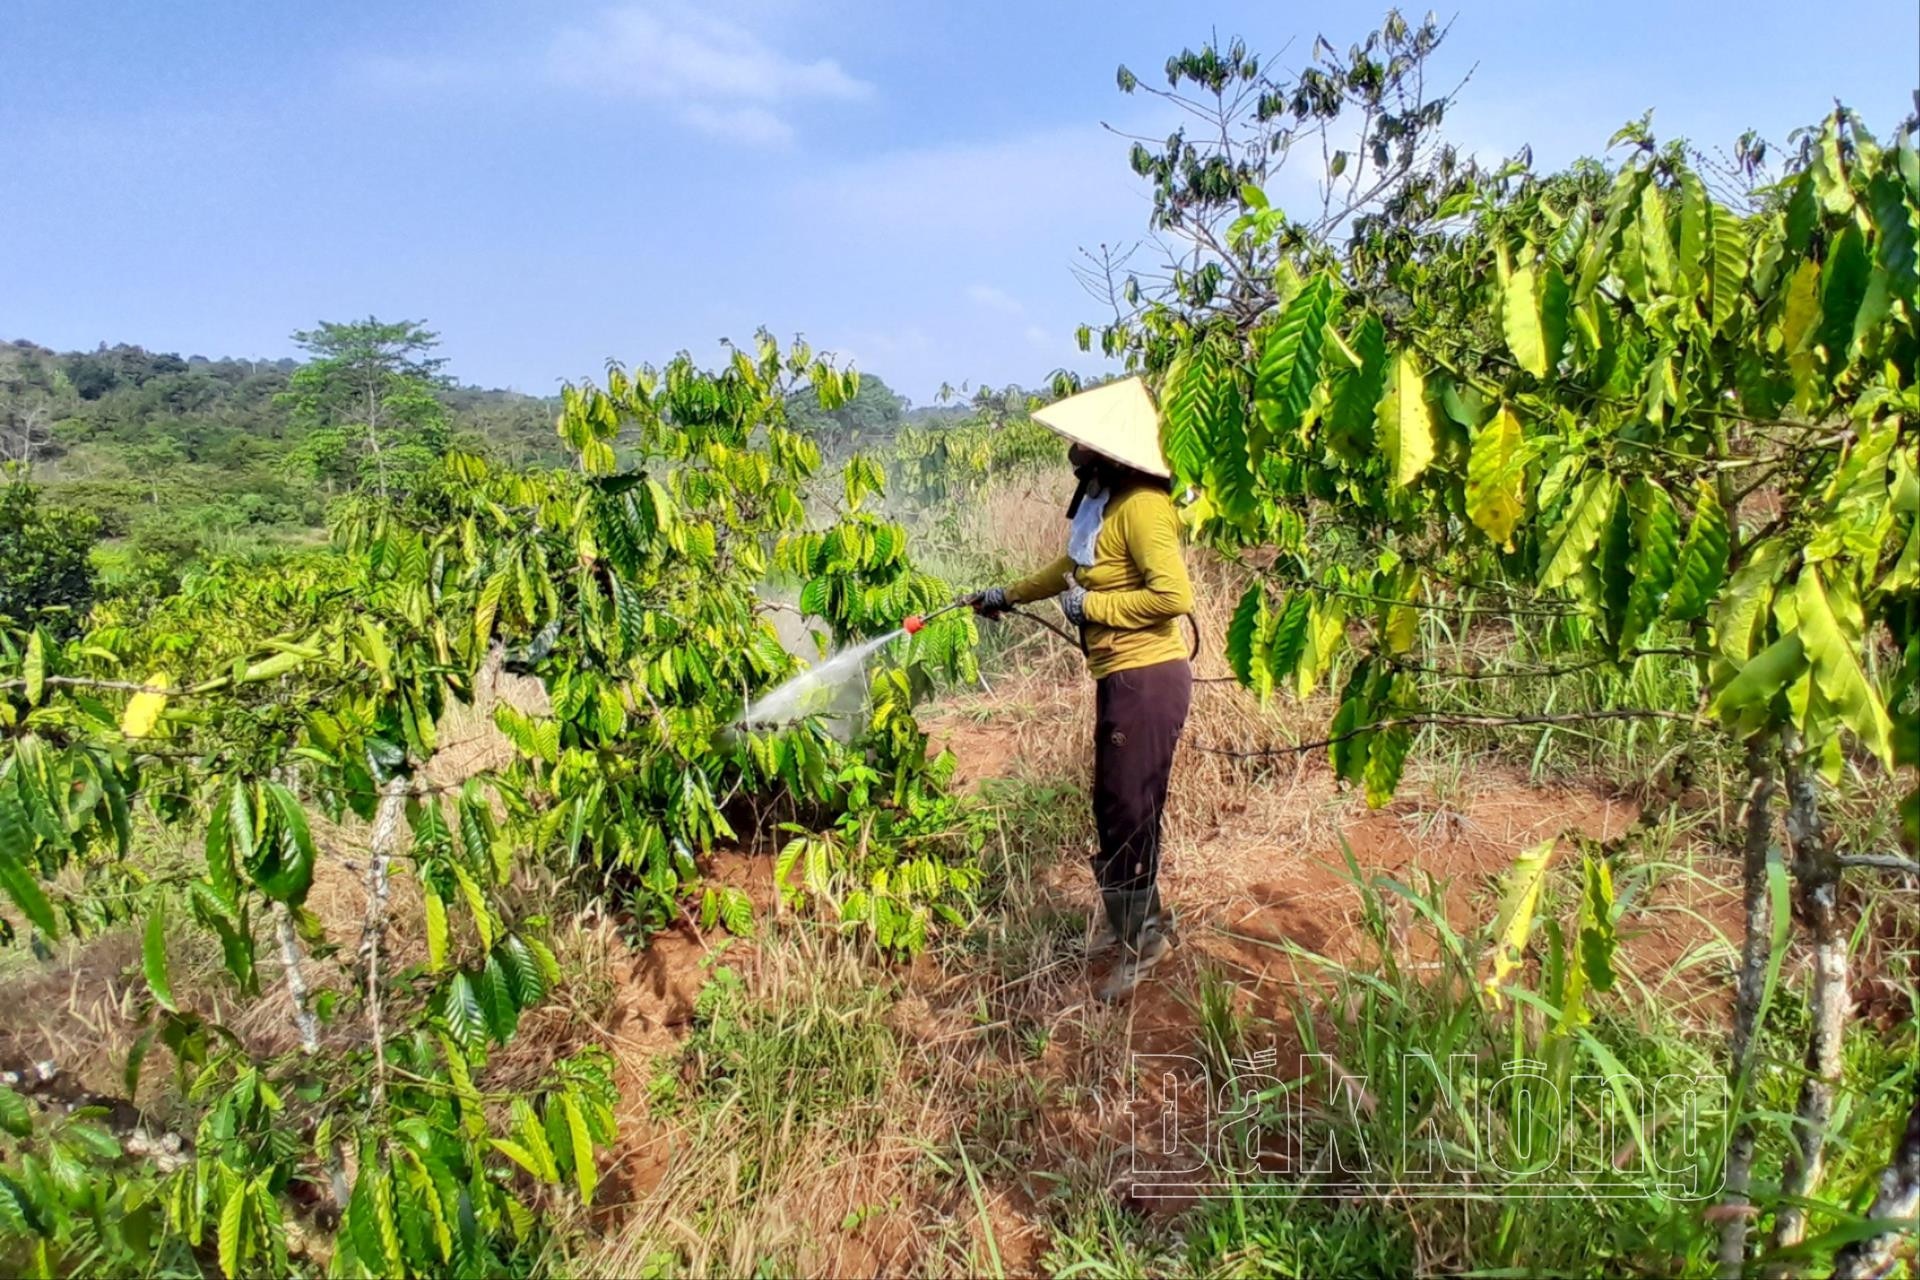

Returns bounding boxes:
[0,317,1025,570]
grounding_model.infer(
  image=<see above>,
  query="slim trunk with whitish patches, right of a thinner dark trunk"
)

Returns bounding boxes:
[1774,731,1853,1249]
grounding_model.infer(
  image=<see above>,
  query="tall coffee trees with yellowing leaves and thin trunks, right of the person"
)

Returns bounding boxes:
[1083,15,1920,1274]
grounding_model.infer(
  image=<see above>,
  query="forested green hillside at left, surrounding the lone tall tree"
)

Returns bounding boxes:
[0,326,561,562]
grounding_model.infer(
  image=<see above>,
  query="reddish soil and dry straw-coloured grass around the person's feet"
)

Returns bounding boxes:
[576,693,1738,1274]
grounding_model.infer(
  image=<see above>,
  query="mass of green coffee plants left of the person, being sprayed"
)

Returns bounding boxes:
[0,336,977,1276]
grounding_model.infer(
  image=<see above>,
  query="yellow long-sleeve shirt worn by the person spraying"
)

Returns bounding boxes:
[1006,486,1194,679]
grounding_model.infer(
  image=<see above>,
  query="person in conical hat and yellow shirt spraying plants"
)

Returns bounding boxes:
[968,378,1192,1000]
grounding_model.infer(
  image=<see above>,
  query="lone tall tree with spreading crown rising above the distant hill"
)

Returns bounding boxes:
[282,317,447,497]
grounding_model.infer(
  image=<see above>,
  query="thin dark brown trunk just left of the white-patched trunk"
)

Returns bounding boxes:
[1720,735,1774,1276]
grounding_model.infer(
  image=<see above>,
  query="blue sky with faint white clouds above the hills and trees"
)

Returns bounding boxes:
[0,0,1920,401]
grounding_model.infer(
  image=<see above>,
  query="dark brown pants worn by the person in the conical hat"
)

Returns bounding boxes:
[1092,658,1194,892]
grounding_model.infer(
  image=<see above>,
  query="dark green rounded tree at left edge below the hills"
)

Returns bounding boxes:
[0,466,100,635]
